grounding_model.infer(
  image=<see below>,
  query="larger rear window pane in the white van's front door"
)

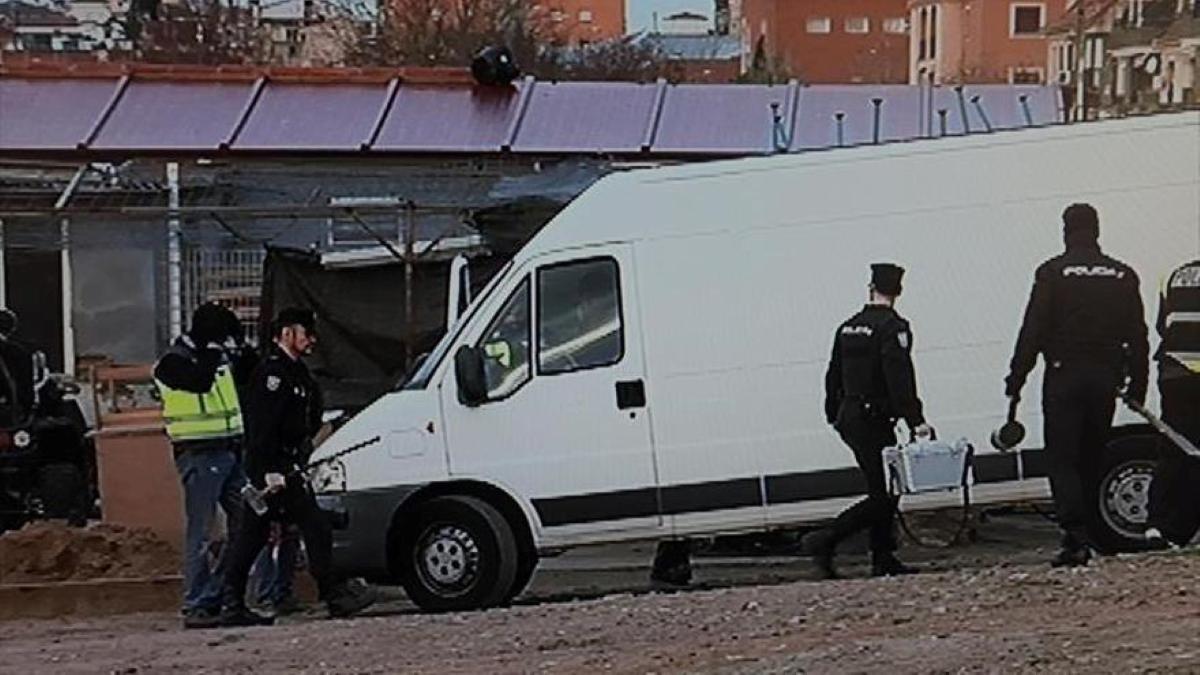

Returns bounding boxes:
[538,258,625,375]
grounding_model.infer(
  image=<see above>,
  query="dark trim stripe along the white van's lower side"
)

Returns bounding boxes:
[533,450,1045,527]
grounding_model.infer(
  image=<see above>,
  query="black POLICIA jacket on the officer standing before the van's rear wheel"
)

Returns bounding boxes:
[1004,245,1150,400]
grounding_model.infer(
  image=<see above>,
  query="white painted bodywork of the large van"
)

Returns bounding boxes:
[324,112,1200,557]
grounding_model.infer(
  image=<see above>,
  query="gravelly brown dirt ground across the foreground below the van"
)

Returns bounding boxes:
[0,509,1200,674]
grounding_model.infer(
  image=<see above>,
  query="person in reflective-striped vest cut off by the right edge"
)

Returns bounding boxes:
[1146,261,1200,548]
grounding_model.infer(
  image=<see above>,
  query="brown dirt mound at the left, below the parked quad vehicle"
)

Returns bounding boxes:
[0,521,180,584]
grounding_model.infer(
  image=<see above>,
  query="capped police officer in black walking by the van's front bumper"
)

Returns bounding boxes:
[221,309,373,626]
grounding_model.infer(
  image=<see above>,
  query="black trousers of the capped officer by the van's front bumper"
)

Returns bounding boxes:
[223,477,337,607]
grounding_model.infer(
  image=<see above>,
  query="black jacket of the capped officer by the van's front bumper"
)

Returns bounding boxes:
[244,345,323,486]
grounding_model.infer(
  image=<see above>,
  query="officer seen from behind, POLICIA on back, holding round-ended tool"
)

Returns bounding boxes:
[1004,204,1150,567]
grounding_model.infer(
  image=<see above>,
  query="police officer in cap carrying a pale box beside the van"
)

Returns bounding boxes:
[802,263,932,579]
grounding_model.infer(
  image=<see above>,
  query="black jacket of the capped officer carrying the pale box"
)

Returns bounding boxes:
[824,305,925,429]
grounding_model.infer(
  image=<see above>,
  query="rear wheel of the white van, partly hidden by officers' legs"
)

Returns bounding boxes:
[1088,435,1159,554]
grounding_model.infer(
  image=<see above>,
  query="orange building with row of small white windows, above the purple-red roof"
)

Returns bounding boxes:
[740,0,908,84]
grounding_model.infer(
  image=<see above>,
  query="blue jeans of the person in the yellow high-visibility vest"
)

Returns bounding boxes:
[175,449,246,613]
